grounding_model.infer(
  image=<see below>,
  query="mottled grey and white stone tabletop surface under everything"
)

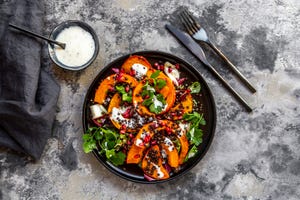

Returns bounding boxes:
[0,0,300,200]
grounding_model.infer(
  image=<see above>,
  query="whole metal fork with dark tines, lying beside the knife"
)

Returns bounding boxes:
[180,10,256,93]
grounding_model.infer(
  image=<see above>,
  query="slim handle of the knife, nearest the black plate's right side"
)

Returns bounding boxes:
[204,63,253,112]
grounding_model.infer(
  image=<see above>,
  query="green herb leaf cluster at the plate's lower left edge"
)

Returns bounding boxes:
[82,127,127,165]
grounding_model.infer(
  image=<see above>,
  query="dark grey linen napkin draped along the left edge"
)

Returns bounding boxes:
[0,0,60,159]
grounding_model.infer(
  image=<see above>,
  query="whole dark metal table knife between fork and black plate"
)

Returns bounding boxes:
[166,24,252,112]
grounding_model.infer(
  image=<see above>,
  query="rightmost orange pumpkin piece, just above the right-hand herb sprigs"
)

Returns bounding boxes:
[170,93,193,120]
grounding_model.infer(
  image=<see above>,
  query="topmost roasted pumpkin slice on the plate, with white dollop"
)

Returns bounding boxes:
[121,55,152,79]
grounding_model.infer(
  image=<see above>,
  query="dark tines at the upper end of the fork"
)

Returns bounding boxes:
[179,9,201,35]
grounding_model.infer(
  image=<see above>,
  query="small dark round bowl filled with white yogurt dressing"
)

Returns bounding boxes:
[48,20,99,71]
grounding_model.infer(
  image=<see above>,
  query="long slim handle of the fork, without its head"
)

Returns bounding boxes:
[207,41,256,93]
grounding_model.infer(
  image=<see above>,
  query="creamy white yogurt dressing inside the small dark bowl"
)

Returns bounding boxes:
[54,26,95,67]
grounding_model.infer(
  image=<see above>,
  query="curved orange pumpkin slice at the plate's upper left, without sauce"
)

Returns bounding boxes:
[94,73,138,104]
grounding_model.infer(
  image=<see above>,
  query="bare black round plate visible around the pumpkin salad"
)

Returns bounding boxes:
[83,51,216,183]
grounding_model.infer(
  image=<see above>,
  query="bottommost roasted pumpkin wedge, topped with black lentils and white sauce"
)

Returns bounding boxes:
[142,145,170,180]
